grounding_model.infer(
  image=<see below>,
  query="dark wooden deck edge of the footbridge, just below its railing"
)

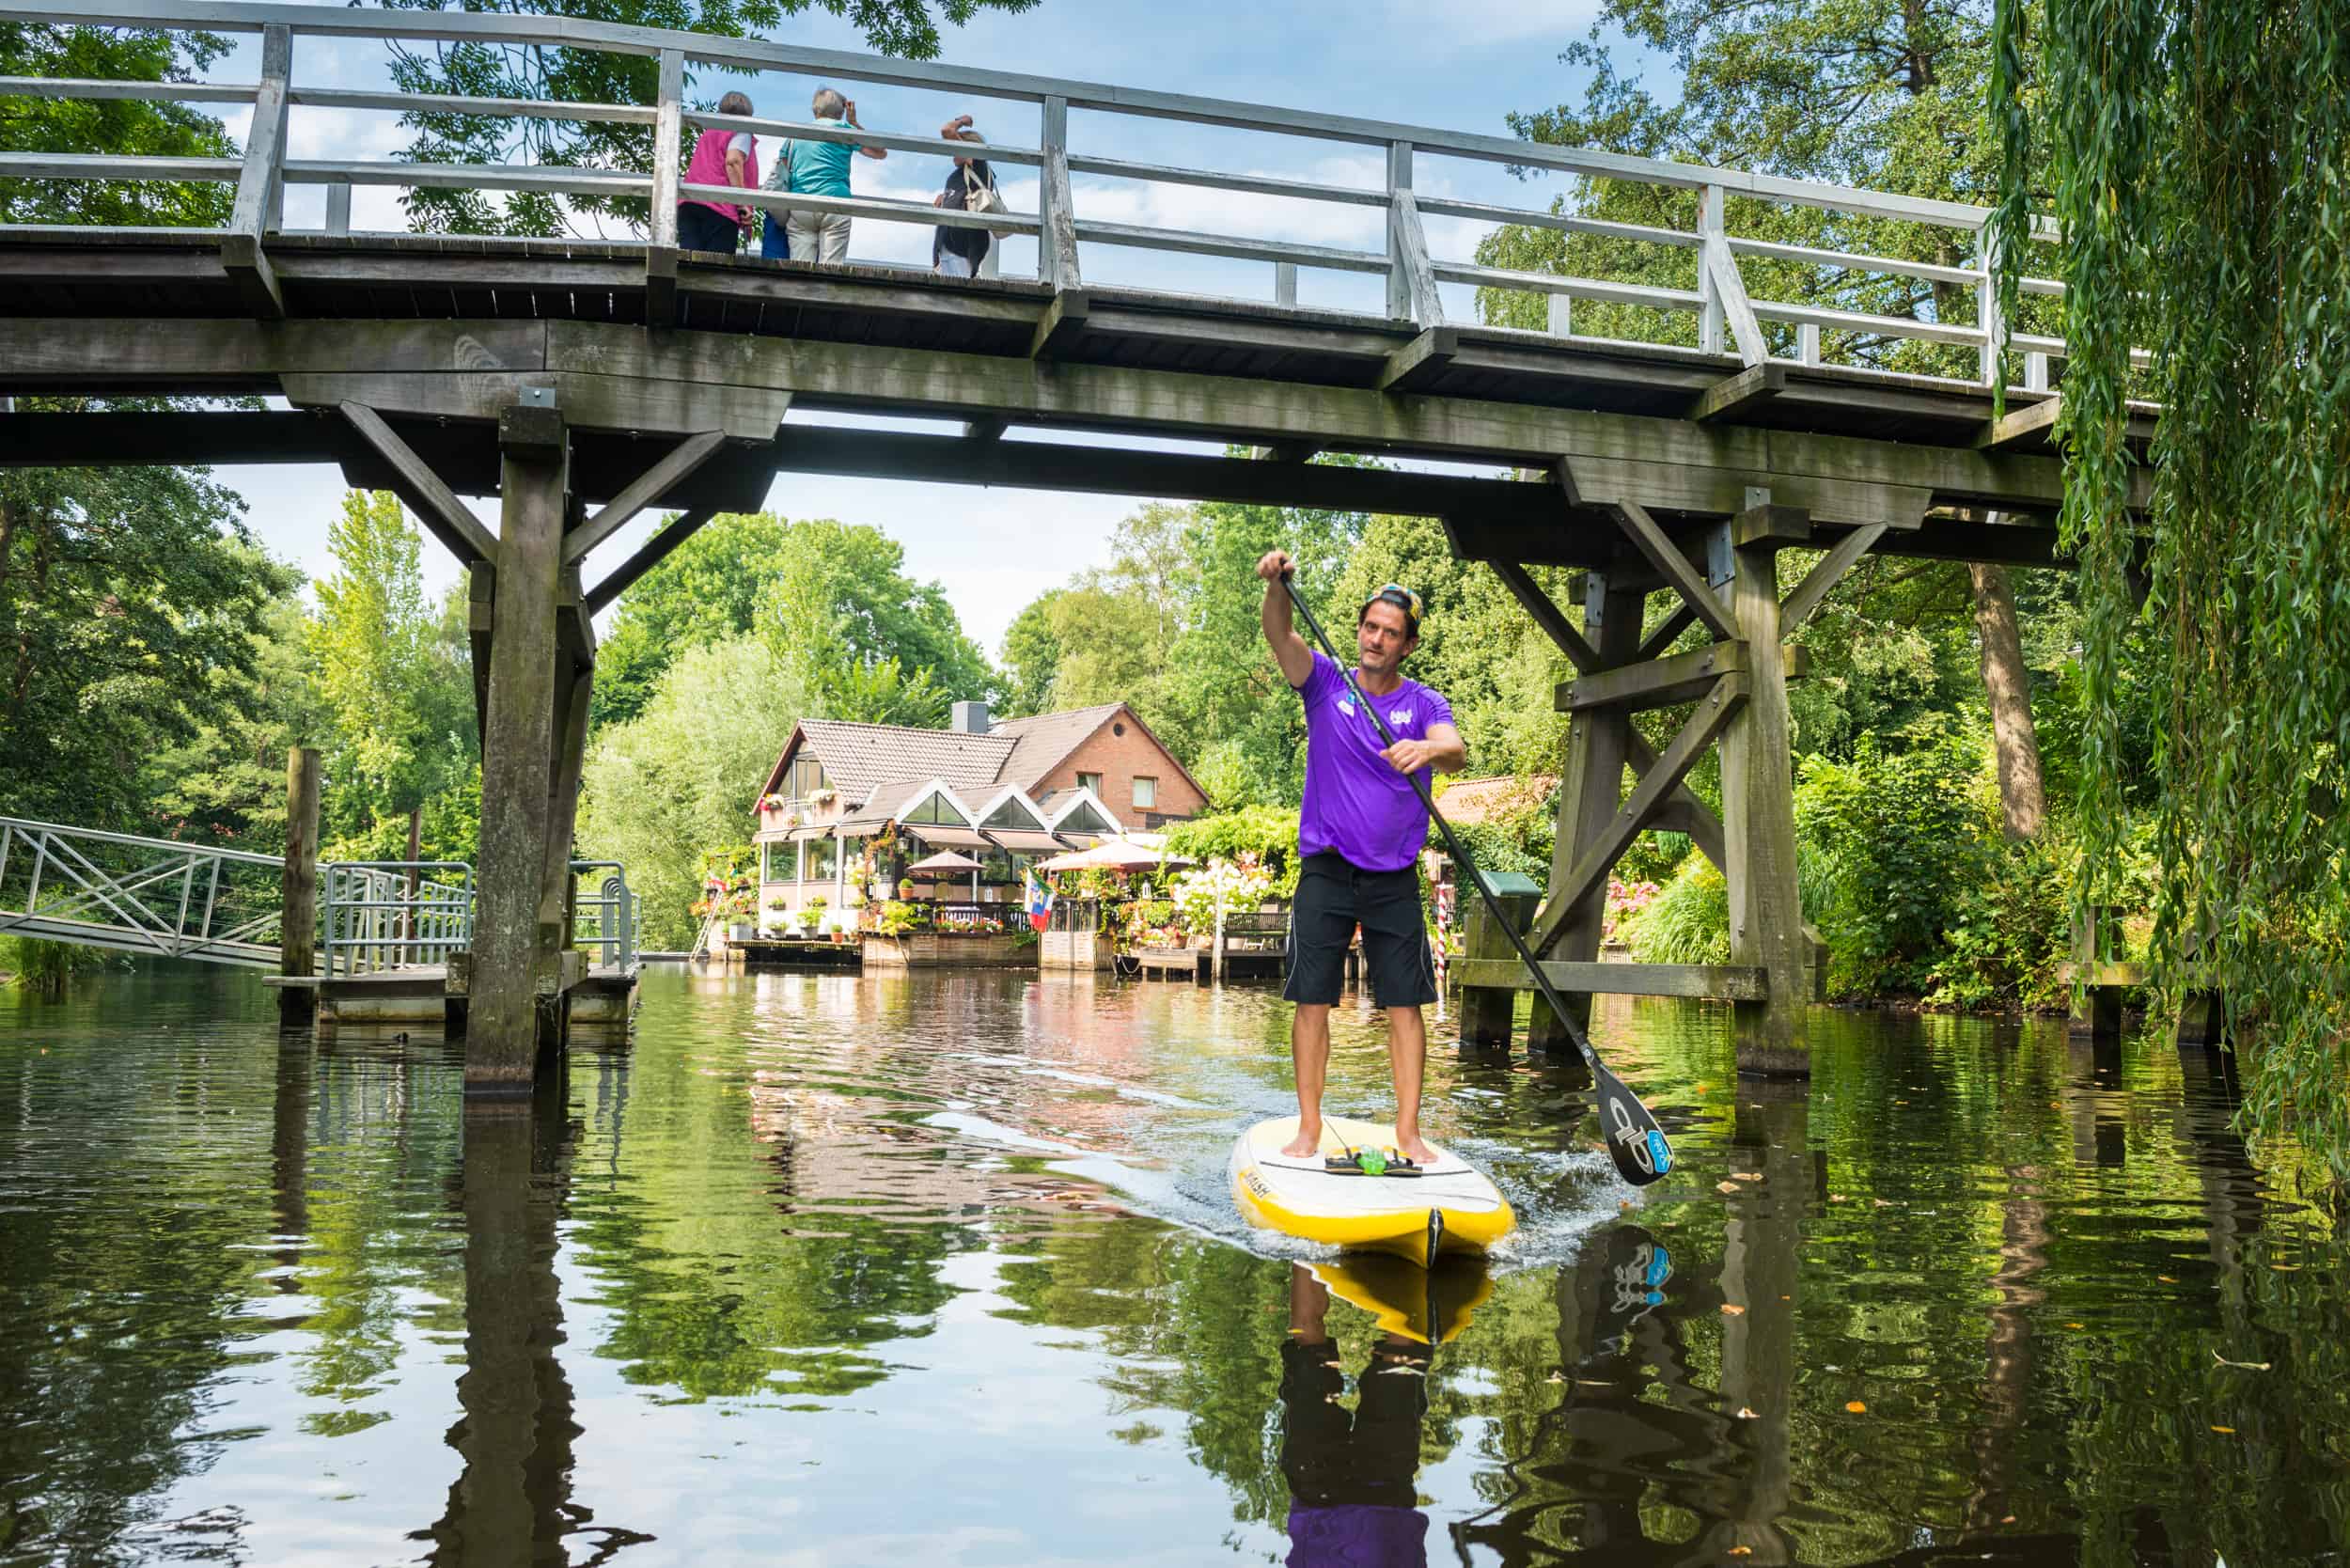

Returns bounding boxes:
[0,230,2049,451]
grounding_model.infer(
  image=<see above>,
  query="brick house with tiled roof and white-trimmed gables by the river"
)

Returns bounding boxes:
[752,703,1208,919]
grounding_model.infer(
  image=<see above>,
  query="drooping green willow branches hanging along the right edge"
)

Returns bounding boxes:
[2000,0,2350,1183]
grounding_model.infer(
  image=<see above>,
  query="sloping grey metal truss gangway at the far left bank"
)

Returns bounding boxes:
[0,816,285,968]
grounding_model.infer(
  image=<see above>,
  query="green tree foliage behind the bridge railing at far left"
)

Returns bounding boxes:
[0,22,238,228]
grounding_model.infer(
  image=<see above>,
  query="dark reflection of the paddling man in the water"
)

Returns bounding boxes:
[1281,1264,1429,1568]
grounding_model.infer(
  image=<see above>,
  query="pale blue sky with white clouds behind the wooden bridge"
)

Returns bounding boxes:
[193,0,1643,653]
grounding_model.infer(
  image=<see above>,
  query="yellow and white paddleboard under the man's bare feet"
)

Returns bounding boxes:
[1231,1117,1518,1267]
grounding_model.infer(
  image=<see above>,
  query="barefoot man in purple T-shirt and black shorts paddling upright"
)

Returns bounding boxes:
[1258,550,1469,1164]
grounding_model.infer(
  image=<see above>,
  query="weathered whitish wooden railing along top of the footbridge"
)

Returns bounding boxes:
[0,0,2096,388]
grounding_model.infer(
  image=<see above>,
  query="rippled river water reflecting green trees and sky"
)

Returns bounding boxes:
[0,968,2350,1568]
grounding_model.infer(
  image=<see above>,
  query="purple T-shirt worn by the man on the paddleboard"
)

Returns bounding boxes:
[1297,653,1452,872]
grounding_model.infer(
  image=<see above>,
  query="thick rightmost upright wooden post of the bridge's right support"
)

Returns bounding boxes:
[1723,514,1812,1076]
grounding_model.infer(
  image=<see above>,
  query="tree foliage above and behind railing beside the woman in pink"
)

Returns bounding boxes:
[385,0,1037,235]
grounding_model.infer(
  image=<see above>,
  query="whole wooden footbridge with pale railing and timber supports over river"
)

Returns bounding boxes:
[0,0,2134,1089]
